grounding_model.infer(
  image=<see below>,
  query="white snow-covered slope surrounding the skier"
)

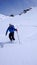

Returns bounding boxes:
[0,7,37,65]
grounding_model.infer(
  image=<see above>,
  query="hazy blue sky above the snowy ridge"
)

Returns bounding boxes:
[0,0,37,15]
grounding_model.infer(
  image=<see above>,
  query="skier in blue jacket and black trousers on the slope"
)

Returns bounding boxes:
[6,24,17,41]
